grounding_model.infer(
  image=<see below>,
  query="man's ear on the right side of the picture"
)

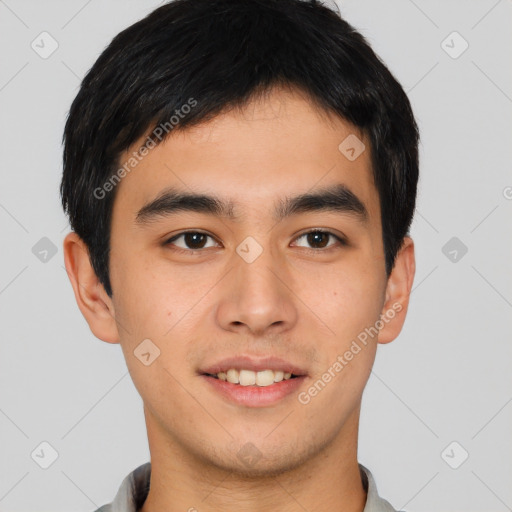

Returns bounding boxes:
[378,236,416,343]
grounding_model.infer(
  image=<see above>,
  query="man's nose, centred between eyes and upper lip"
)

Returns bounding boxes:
[217,242,298,336]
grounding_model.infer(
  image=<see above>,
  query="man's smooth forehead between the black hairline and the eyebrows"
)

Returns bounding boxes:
[114,89,379,226]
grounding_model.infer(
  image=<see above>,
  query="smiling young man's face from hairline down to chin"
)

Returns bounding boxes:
[66,89,414,474]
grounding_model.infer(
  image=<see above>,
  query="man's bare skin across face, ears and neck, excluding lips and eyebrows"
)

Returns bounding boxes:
[64,88,415,512]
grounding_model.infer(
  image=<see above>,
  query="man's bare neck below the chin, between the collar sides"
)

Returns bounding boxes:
[140,410,366,512]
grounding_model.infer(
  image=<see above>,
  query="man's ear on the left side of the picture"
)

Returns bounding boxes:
[63,232,119,343]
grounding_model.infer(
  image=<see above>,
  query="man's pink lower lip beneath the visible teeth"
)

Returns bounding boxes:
[201,375,306,407]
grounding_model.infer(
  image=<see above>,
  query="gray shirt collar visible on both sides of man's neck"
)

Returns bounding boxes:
[95,462,397,512]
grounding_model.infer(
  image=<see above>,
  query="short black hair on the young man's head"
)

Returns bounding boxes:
[60,0,419,296]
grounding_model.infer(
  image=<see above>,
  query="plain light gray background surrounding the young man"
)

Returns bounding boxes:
[0,0,512,512]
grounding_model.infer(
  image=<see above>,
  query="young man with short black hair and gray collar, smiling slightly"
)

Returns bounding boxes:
[61,0,418,512]
